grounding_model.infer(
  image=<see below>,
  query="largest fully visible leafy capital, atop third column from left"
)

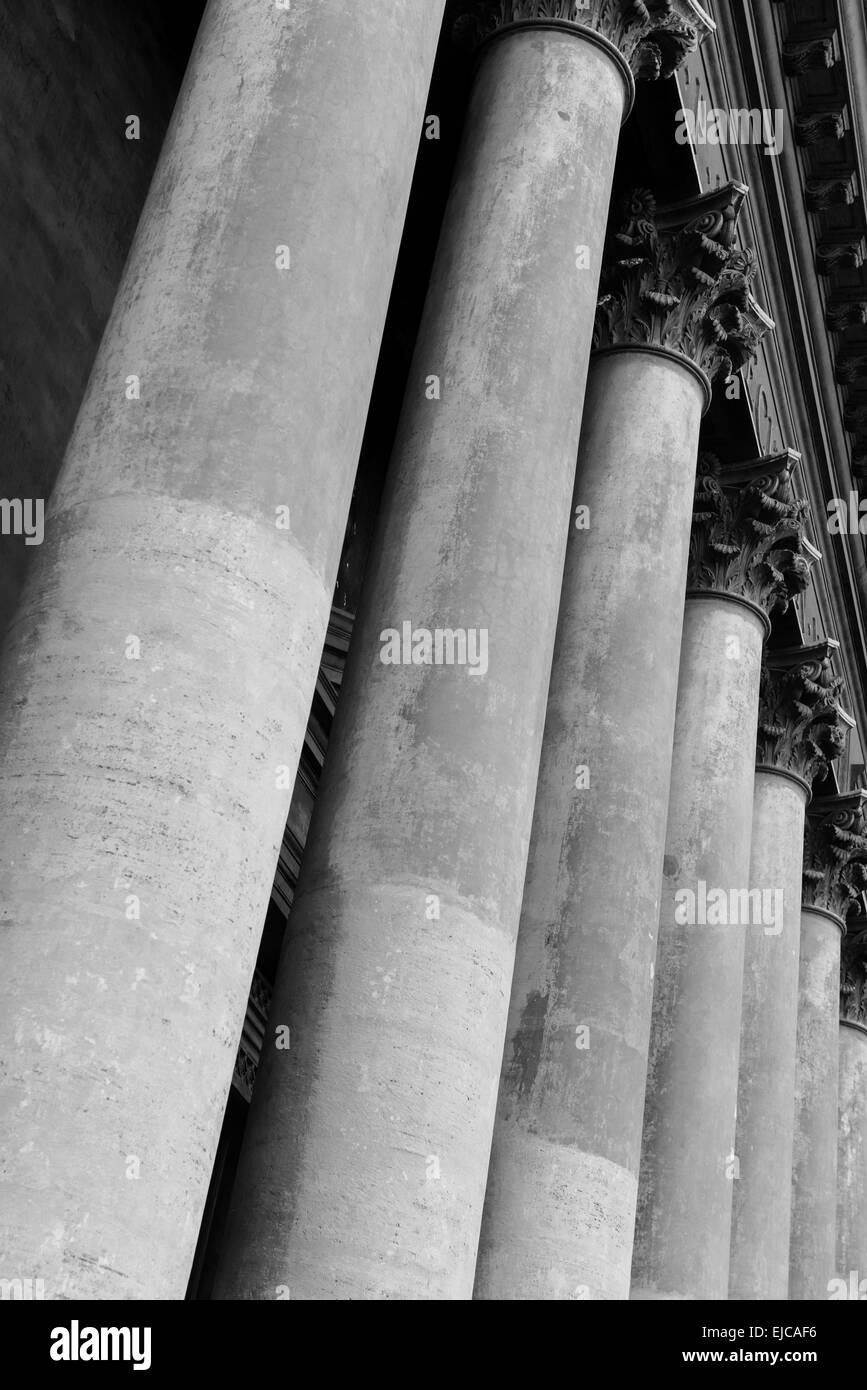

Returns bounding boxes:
[593,183,774,378]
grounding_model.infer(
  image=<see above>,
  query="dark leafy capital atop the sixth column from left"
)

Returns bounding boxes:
[803,791,867,919]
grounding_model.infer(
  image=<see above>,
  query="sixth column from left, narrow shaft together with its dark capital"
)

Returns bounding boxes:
[789,791,867,1301]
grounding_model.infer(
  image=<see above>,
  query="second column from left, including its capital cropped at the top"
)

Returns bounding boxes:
[218,4,711,1298]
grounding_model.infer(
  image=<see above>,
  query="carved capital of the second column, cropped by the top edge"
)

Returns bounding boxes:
[454,0,714,81]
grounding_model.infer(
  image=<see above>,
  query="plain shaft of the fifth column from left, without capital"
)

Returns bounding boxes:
[728,767,809,1300]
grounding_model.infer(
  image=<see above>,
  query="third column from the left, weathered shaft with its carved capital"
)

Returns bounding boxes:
[475,185,756,1300]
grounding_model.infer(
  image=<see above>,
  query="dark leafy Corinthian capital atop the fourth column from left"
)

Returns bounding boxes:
[688,449,818,614]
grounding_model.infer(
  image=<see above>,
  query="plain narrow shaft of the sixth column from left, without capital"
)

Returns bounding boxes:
[788,906,845,1300]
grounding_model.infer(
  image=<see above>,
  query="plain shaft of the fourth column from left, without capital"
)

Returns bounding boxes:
[632,592,766,1298]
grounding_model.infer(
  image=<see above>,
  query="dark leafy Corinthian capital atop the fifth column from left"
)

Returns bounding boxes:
[756,641,852,784]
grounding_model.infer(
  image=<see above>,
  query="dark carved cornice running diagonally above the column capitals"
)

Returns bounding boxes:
[705,0,867,785]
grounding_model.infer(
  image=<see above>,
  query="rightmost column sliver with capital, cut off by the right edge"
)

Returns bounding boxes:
[829,916,867,1300]
